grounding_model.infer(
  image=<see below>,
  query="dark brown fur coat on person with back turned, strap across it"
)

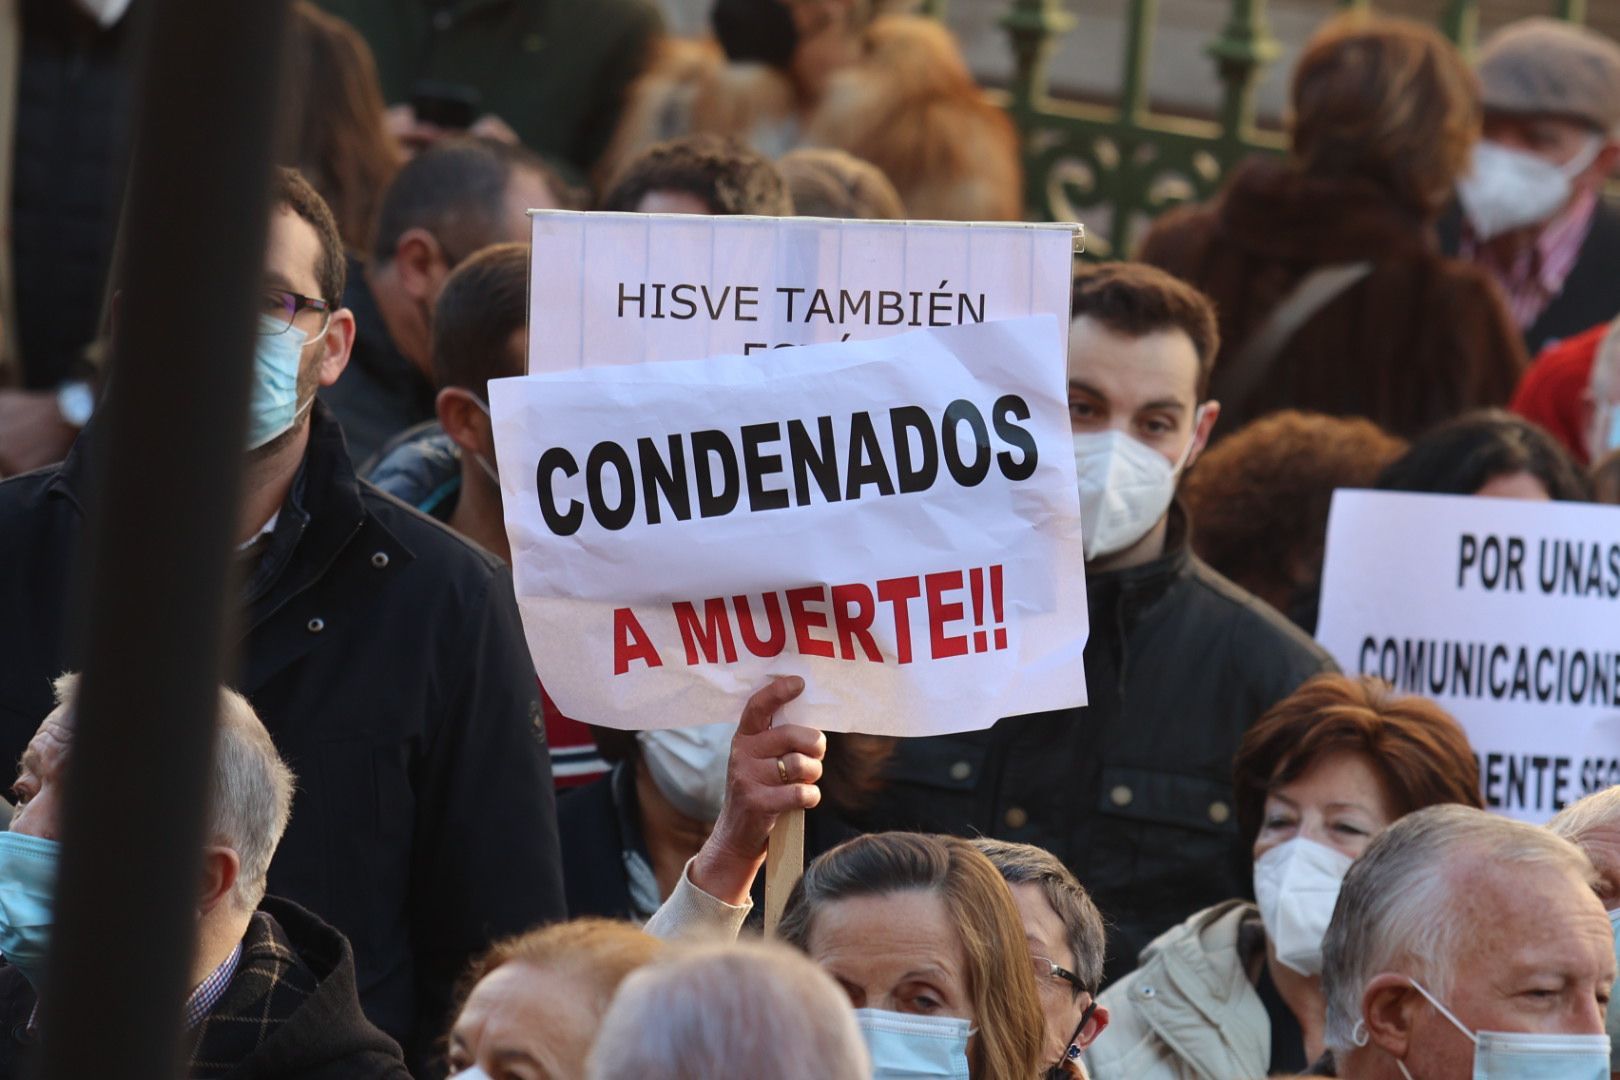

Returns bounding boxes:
[1137,159,1526,439]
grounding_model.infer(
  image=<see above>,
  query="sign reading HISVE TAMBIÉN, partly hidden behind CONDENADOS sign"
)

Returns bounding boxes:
[528,210,1076,374]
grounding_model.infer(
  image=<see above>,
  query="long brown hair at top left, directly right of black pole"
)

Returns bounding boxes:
[282,0,400,254]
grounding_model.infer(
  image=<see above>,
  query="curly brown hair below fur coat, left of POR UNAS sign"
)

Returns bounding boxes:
[1181,410,1406,612]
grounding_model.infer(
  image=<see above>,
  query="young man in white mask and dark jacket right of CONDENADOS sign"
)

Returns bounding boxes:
[863,264,1333,976]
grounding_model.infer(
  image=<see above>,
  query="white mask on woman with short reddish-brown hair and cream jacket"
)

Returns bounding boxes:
[1254,836,1353,975]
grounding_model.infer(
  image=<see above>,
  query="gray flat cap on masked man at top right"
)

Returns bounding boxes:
[1479,18,1620,134]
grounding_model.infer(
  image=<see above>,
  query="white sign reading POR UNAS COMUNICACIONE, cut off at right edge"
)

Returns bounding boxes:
[1317,491,1620,823]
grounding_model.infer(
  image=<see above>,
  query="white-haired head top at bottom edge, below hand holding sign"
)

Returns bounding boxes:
[586,942,872,1080]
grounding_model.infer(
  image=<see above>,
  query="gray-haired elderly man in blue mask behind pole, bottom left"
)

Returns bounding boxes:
[0,674,410,1080]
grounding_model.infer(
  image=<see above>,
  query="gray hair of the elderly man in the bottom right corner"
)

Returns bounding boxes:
[1322,803,1596,1054]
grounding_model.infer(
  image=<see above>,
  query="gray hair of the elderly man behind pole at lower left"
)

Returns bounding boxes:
[53,672,295,912]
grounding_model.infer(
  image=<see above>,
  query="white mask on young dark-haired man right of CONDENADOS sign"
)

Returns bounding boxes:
[1074,406,1204,562]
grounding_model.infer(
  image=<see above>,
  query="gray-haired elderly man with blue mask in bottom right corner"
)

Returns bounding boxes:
[1322,805,1615,1080]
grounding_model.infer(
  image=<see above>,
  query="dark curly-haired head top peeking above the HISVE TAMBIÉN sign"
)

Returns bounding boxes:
[599,134,794,217]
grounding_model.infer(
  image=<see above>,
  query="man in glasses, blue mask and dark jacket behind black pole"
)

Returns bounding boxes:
[0,170,564,1075]
